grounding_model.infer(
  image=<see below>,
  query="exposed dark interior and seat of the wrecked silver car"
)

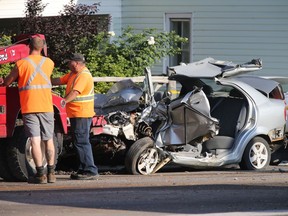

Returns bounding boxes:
[170,78,248,155]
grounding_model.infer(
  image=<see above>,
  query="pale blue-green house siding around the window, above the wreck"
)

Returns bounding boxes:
[122,0,288,76]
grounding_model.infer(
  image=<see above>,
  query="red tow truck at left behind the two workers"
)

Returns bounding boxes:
[0,34,67,181]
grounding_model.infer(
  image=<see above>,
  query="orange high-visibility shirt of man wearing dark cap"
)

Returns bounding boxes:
[60,67,95,118]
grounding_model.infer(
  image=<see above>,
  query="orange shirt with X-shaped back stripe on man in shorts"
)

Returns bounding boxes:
[16,55,54,113]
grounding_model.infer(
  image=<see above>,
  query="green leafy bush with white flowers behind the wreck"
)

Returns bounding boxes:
[77,27,188,92]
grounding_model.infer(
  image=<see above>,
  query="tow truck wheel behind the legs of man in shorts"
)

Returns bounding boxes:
[7,126,59,181]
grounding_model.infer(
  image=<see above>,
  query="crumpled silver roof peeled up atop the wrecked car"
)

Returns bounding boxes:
[169,57,262,78]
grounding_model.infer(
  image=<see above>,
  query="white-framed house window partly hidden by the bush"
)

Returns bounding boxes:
[165,14,192,66]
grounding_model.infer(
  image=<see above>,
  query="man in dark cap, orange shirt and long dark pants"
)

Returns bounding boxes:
[51,53,98,180]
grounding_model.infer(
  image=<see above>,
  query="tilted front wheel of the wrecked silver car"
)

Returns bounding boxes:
[125,137,159,175]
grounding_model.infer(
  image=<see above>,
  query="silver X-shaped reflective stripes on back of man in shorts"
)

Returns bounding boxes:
[19,57,52,92]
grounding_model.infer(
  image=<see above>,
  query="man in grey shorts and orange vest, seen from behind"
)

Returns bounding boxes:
[3,36,56,184]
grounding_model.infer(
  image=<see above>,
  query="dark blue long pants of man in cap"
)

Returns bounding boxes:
[70,118,98,174]
